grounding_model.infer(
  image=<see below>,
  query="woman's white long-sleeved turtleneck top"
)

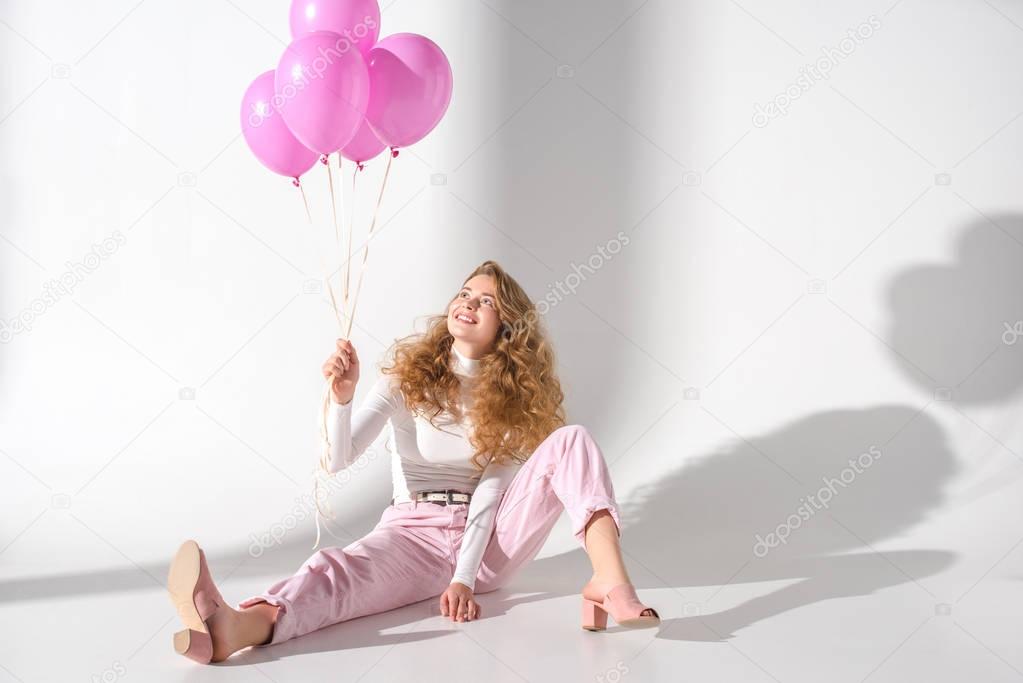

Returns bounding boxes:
[327,347,522,589]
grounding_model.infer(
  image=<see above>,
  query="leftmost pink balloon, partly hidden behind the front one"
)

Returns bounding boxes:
[241,70,317,178]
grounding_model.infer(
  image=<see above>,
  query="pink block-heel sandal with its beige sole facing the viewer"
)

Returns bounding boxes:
[167,540,224,664]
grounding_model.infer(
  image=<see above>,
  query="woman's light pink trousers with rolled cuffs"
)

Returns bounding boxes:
[238,424,622,645]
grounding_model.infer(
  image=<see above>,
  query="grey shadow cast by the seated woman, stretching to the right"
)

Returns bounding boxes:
[499,405,957,640]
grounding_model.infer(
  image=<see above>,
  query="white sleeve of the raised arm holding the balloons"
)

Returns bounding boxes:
[326,374,402,474]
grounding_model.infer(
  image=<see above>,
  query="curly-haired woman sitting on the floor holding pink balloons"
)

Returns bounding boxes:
[168,261,660,664]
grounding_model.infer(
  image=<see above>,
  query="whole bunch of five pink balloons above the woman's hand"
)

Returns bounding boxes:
[241,0,453,182]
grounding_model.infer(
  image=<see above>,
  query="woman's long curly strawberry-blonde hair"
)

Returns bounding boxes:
[381,260,566,470]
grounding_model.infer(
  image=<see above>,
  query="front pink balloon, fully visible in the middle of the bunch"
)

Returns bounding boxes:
[274,31,369,154]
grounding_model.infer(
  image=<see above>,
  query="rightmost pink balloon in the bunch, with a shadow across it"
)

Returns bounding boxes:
[366,33,453,147]
